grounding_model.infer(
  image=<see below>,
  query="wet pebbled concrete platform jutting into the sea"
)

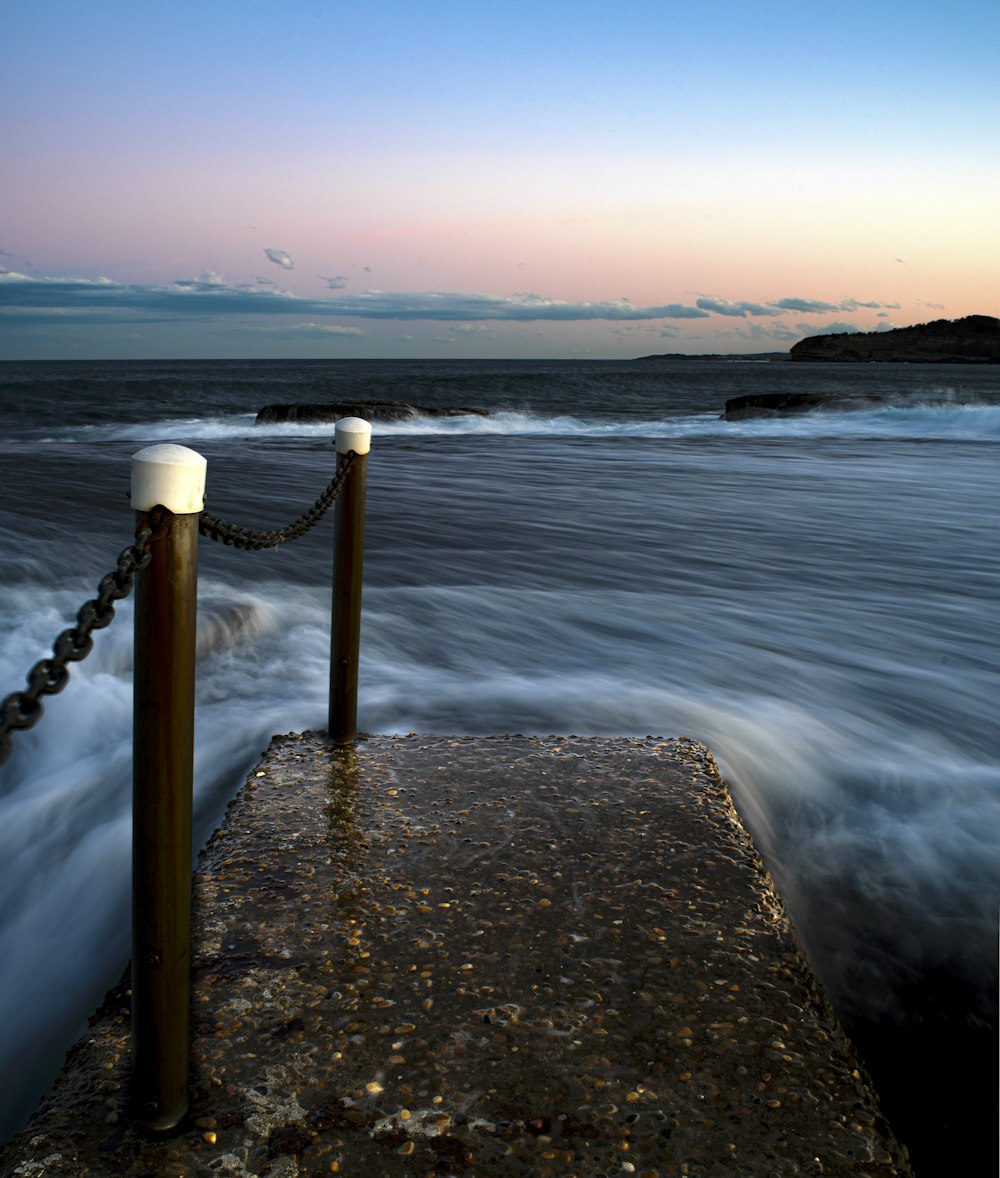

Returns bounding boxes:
[0,734,910,1178]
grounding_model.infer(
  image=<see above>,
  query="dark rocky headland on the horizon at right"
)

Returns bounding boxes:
[789,315,1000,364]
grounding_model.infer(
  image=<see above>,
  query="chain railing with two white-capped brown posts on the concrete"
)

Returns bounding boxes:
[0,418,371,1132]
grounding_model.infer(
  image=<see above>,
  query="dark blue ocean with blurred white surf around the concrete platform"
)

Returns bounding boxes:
[0,359,1000,1174]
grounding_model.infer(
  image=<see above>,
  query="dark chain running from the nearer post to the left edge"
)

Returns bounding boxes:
[0,523,158,765]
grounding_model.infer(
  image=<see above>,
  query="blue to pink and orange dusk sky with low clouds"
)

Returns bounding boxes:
[0,0,1000,359]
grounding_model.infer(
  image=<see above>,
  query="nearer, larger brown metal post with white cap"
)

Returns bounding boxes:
[132,445,206,1132]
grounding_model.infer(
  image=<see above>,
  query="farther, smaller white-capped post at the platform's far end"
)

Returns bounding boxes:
[330,417,371,744]
